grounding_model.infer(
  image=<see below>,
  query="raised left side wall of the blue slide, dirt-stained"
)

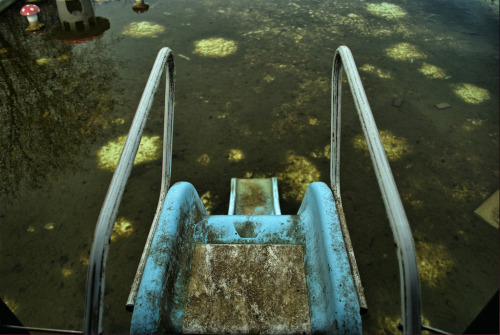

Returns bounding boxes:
[130,182,208,334]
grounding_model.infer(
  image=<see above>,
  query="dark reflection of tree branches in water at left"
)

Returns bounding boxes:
[0,10,117,196]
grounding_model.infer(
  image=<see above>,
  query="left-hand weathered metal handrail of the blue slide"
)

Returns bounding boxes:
[84,48,175,334]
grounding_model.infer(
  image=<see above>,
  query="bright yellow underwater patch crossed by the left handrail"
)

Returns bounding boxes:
[97,136,162,171]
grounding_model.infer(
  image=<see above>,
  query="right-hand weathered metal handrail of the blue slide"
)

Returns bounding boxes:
[330,46,422,334]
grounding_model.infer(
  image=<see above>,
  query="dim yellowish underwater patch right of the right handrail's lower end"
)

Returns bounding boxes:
[415,241,454,287]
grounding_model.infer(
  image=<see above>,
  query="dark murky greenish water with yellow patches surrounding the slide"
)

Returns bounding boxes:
[0,0,499,333]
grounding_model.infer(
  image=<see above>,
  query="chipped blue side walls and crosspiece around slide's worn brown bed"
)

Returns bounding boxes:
[131,182,362,334]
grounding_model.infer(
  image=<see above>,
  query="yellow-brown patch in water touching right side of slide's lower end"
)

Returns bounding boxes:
[278,152,320,201]
